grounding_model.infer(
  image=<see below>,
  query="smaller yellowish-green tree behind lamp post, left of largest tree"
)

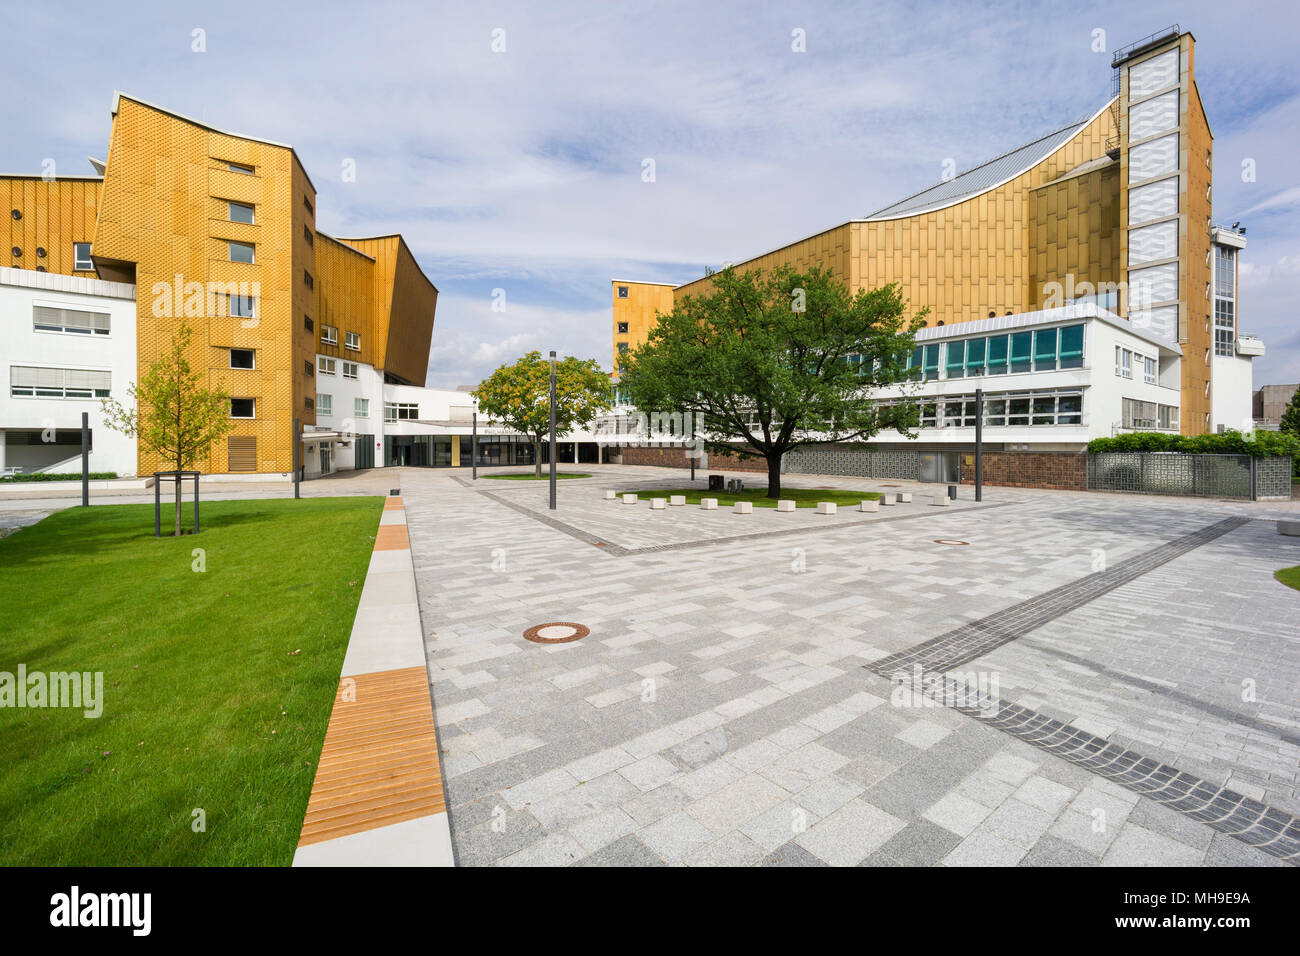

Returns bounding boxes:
[469,350,610,477]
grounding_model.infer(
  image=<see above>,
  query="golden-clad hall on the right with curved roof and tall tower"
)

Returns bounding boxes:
[611,29,1258,434]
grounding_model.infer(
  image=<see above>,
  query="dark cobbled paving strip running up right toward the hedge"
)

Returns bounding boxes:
[871,516,1251,674]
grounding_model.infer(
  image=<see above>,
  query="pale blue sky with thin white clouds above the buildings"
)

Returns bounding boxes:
[0,0,1300,386]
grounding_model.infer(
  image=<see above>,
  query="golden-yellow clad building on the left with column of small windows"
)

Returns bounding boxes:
[0,94,438,475]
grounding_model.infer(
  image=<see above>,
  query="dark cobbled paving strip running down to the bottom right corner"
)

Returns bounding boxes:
[870,665,1300,866]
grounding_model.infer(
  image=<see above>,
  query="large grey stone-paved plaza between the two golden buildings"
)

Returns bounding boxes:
[402,467,1300,866]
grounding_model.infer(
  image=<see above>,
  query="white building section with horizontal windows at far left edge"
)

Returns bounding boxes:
[0,267,137,476]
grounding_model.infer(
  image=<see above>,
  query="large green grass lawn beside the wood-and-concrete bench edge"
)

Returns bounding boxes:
[0,498,384,865]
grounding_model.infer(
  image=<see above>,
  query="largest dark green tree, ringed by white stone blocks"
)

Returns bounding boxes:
[620,267,924,498]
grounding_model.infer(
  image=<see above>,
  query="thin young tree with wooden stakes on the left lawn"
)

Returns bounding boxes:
[103,324,234,536]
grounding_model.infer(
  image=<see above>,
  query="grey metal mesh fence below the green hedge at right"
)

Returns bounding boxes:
[1088,451,1291,498]
